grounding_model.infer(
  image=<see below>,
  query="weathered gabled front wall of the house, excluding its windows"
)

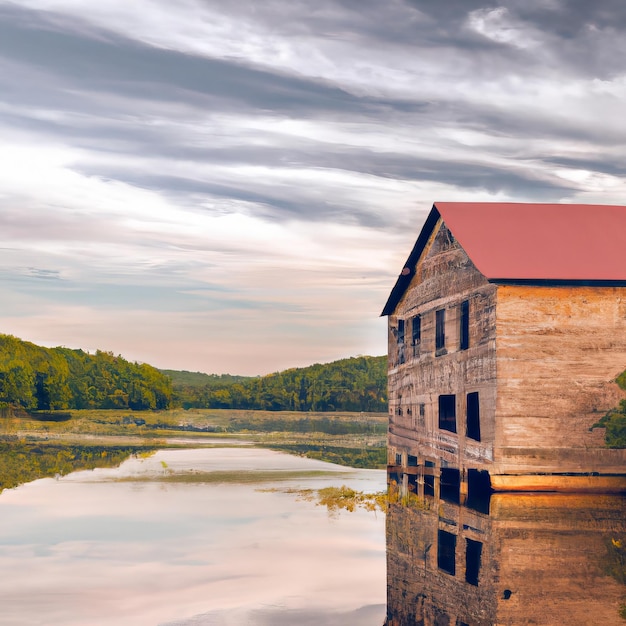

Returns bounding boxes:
[389,222,496,468]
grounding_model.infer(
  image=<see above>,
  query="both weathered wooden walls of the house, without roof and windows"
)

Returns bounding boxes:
[389,220,626,492]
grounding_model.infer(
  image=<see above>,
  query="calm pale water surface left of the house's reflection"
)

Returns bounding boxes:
[0,448,386,626]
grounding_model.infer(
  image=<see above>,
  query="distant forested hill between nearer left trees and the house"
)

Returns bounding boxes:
[166,356,387,412]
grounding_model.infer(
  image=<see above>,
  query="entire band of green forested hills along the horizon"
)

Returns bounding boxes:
[0,334,387,412]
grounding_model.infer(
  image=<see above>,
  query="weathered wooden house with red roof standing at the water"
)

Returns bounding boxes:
[383,202,626,500]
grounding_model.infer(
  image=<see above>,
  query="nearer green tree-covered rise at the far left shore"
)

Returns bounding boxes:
[0,335,172,411]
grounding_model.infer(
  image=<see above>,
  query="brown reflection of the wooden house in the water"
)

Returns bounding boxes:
[386,493,626,626]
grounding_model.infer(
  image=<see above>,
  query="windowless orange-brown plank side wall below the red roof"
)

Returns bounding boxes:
[493,286,626,474]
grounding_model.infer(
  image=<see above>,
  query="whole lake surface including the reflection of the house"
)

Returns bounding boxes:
[0,440,626,626]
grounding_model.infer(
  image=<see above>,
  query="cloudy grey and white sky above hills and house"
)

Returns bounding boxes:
[0,0,626,375]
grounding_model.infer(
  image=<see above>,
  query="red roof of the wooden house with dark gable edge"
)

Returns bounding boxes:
[382,202,626,315]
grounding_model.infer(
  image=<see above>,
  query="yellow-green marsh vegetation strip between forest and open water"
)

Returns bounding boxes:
[0,409,387,490]
